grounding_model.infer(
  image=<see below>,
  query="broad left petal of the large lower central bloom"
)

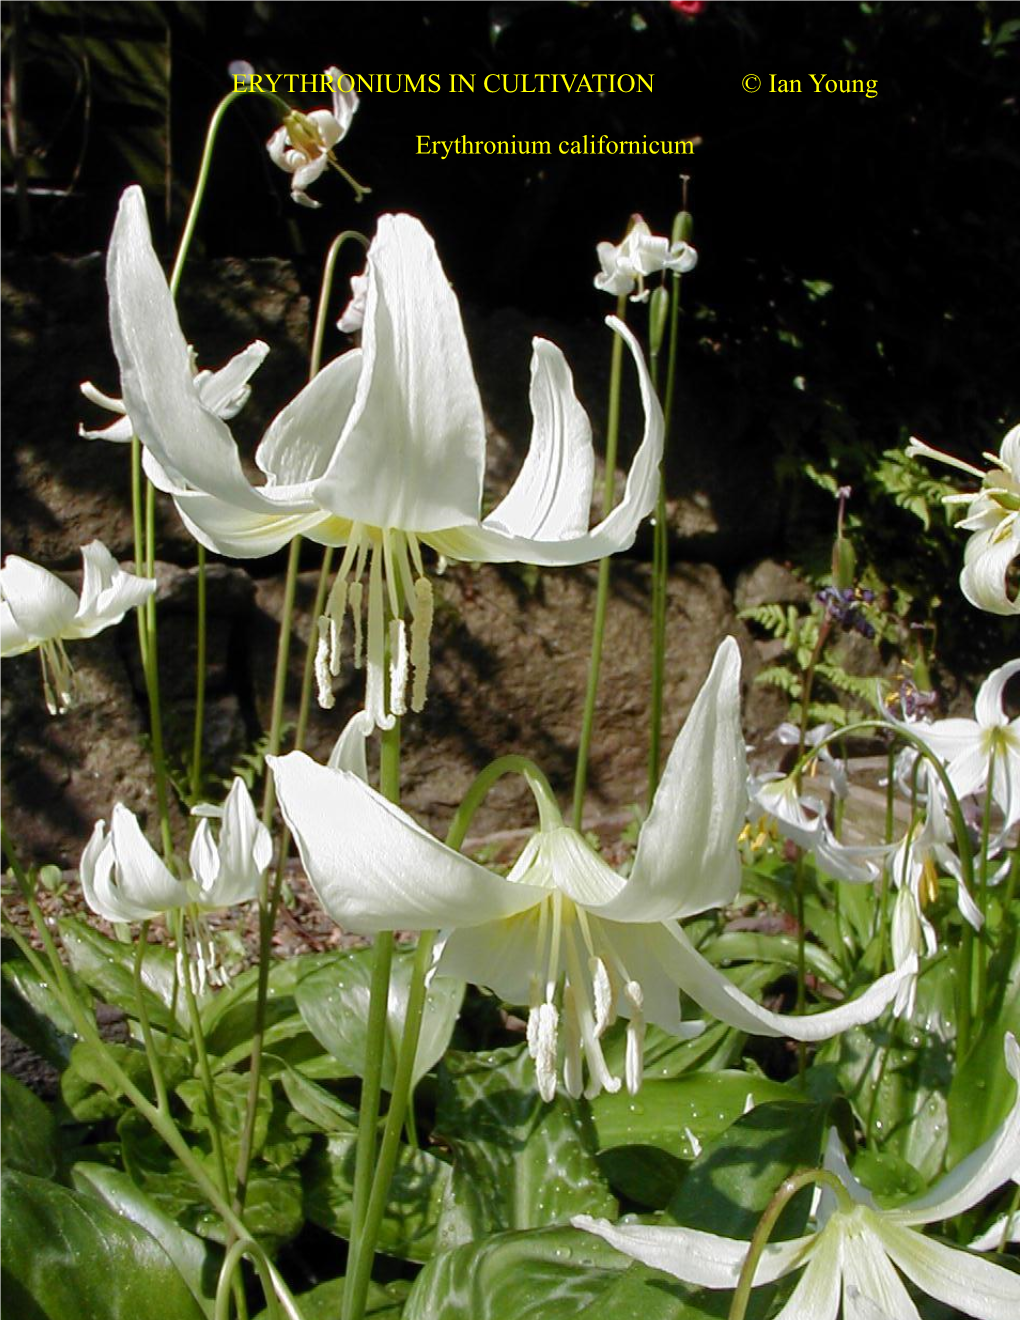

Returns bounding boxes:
[269,751,548,933]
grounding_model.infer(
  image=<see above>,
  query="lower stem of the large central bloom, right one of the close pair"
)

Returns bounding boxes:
[343,931,437,1320]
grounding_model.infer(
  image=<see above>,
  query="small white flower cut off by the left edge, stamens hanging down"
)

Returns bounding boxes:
[0,541,156,715]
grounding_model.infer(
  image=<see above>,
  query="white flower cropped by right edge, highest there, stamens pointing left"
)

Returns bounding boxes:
[907,425,1020,614]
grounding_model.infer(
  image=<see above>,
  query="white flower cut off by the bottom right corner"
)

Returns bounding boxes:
[573,1035,1020,1320]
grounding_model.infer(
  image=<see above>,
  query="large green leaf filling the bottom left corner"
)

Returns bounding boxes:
[0,1172,203,1320]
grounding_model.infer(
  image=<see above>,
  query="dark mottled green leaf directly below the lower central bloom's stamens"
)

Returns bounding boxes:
[434,1045,616,1247]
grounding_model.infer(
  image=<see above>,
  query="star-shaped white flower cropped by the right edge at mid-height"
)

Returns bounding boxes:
[909,660,1020,830]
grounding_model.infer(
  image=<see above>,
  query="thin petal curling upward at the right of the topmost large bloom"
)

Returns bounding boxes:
[425,317,662,566]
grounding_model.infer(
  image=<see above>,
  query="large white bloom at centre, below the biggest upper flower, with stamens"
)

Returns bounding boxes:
[271,638,909,1100]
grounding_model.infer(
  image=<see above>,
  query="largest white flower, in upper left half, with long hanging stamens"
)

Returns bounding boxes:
[108,189,662,727]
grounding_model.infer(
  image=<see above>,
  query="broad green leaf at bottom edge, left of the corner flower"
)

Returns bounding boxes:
[402,1228,629,1320]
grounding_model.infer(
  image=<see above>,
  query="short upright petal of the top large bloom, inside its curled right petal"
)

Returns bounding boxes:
[486,339,595,541]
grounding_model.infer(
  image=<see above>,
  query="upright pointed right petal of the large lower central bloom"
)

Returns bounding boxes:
[598,638,747,921]
